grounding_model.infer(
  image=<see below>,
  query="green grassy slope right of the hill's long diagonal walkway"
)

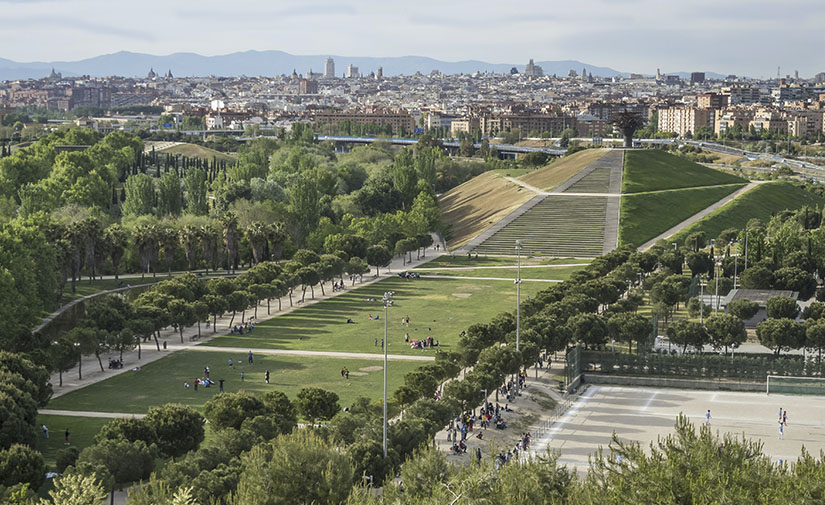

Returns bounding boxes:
[672,181,825,243]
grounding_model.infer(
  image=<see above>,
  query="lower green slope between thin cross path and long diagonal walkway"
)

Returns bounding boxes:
[619,184,743,247]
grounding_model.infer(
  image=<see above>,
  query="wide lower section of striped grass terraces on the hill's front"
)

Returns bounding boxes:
[474,195,607,257]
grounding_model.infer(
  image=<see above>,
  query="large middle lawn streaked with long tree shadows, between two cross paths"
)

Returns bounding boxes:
[201,277,548,354]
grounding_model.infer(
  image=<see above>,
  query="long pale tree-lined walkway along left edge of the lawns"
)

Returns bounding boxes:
[51,246,446,398]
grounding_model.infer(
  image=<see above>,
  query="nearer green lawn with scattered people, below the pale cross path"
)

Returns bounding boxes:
[48,348,424,416]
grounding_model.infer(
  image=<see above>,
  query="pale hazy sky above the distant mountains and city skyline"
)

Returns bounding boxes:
[0,0,825,77]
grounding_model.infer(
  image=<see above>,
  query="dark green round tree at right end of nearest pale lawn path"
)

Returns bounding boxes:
[144,403,204,459]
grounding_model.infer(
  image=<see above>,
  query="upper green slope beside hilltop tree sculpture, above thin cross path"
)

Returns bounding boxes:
[622,149,746,193]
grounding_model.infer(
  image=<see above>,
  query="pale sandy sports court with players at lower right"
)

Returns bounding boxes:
[533,385,825,471]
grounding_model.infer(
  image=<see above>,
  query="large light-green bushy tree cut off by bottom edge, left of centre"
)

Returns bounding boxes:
[237,430,354,505]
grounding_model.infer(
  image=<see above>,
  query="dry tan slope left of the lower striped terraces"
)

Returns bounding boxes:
[438,172,534,248]
